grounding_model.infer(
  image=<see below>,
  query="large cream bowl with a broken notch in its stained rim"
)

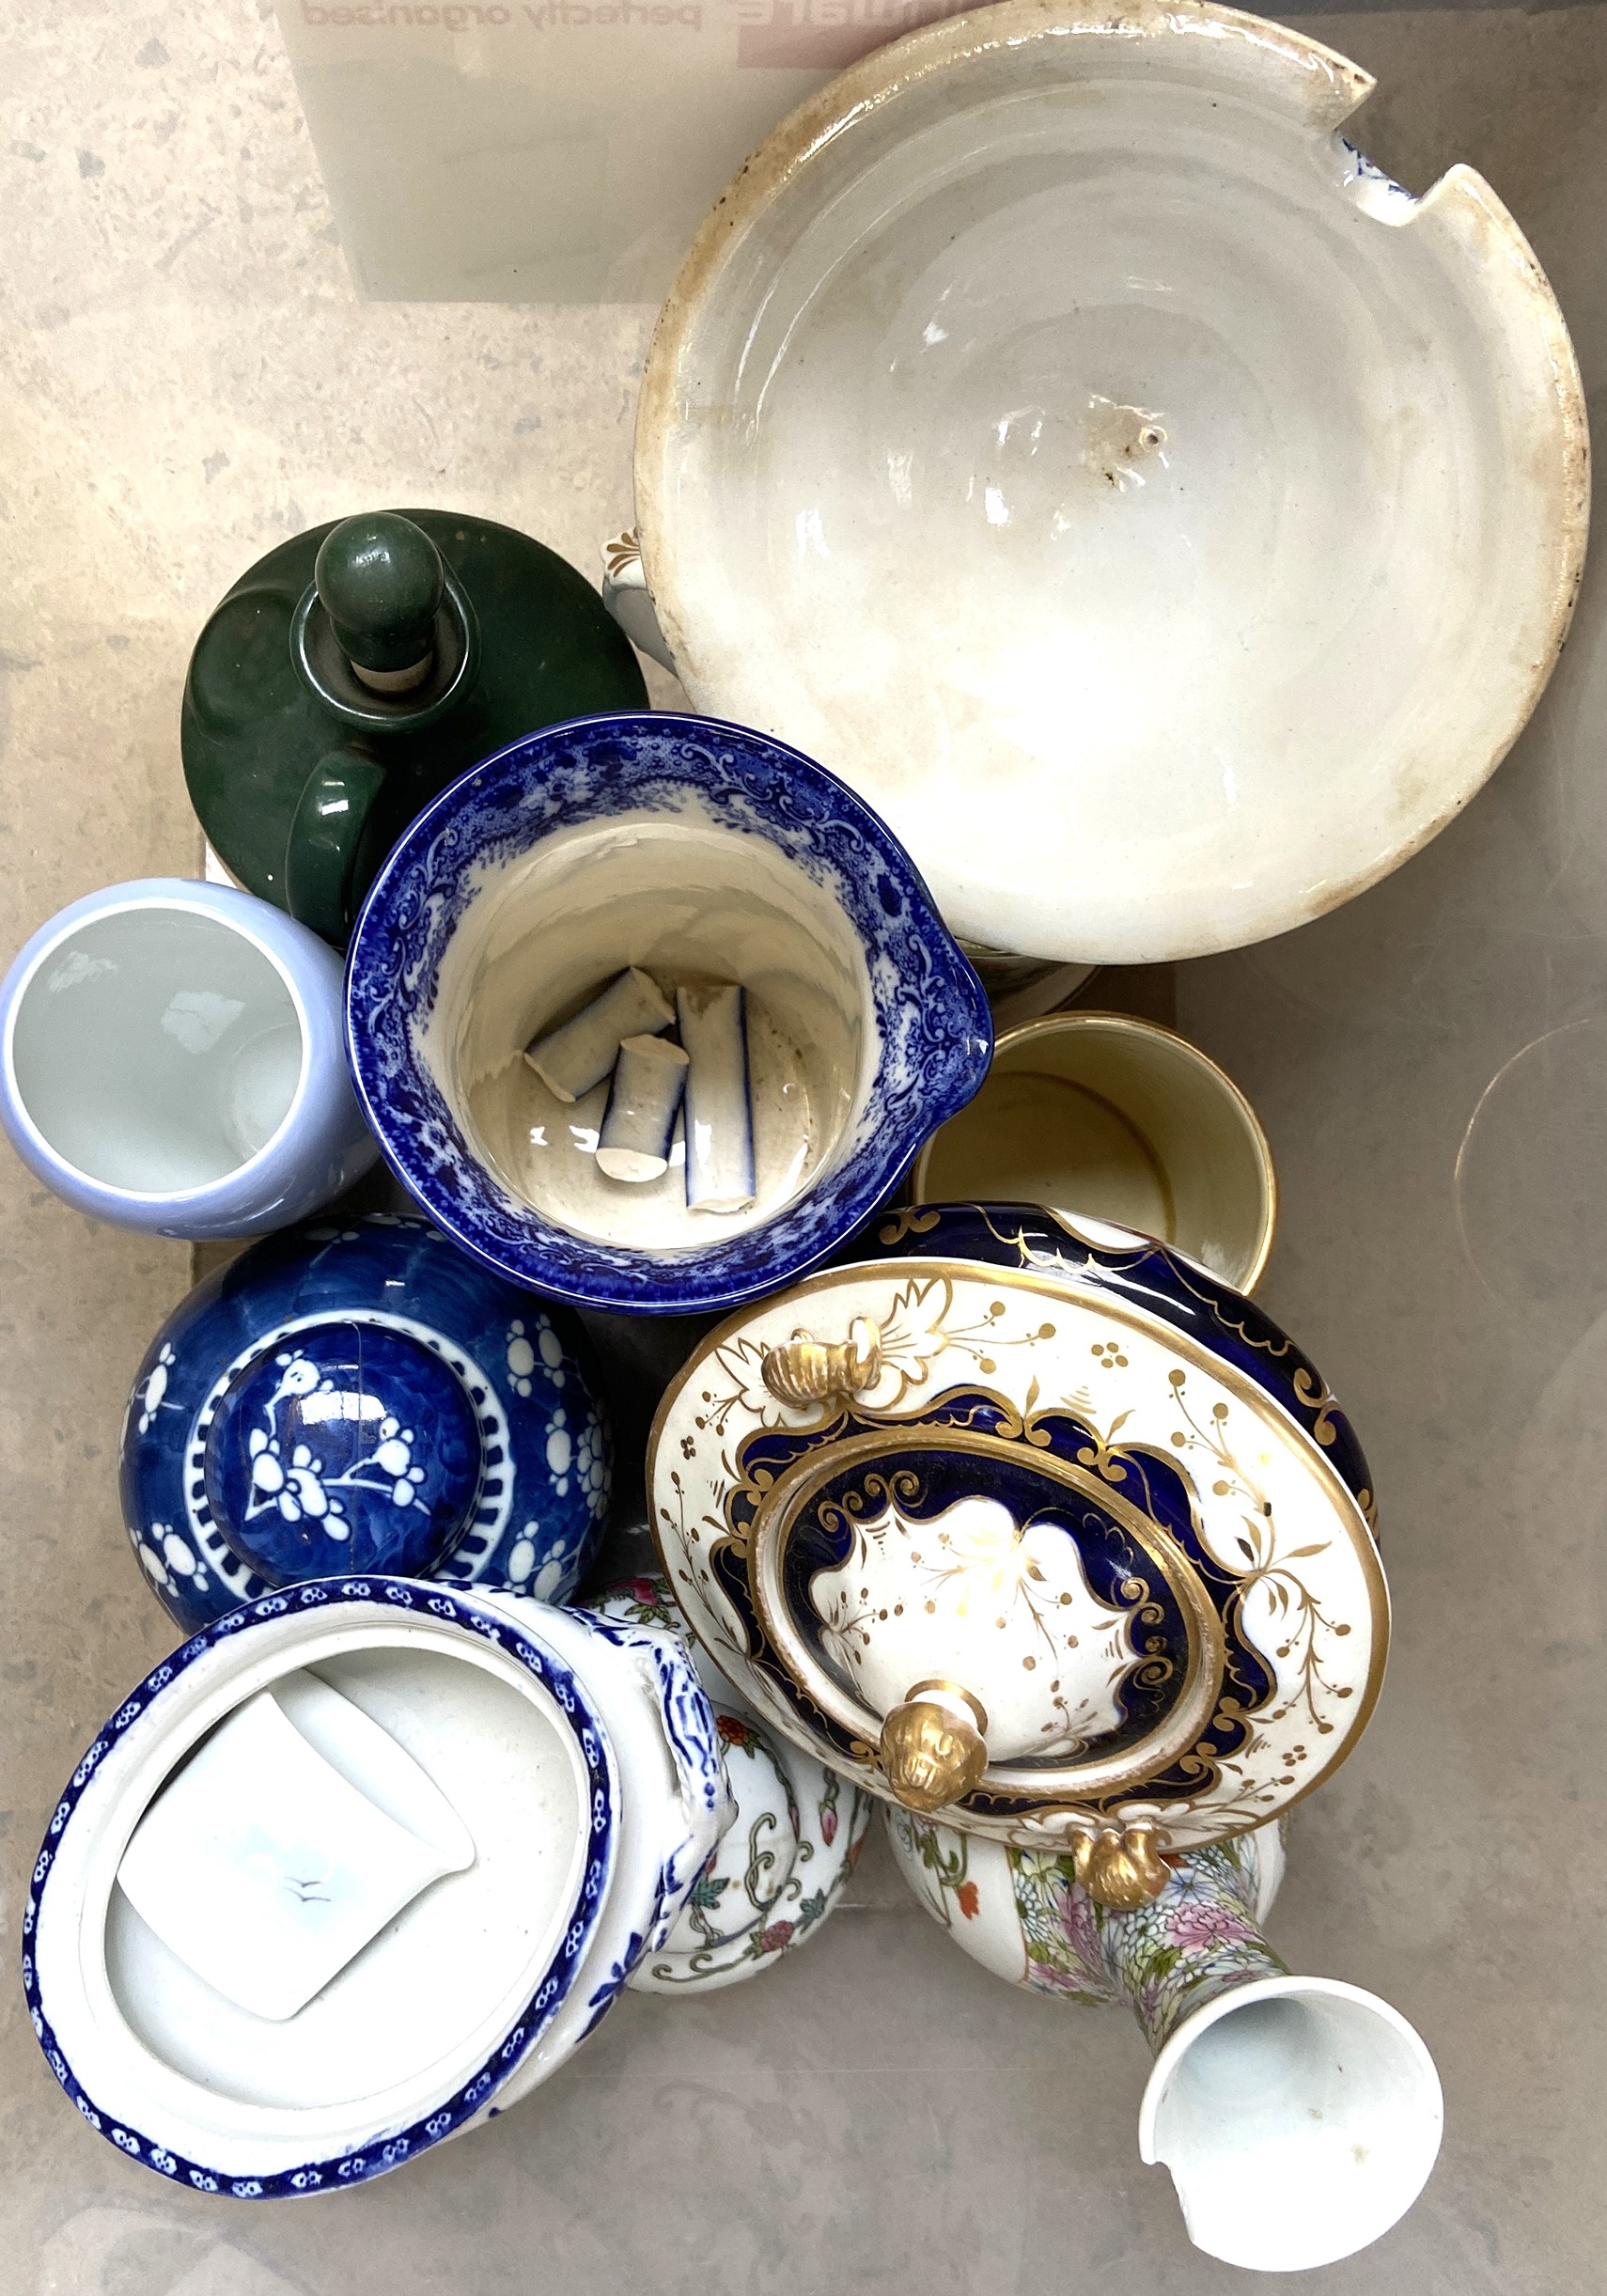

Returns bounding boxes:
[632,0,1588,964]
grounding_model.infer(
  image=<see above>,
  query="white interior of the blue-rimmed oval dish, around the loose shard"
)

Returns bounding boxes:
[37,1618,587,2175]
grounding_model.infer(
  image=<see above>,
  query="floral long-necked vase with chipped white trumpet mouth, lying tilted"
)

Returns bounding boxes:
[886,1807,1444,2271]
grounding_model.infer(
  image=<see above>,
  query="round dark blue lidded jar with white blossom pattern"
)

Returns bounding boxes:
[121,1212,611,1631]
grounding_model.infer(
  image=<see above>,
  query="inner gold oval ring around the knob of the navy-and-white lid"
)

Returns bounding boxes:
[748,1426,1225,1803]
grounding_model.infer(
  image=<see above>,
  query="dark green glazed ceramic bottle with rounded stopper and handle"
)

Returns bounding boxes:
[181,509,647,946]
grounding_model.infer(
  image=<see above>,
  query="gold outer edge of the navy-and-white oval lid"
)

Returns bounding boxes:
[647,1257,1389,1839]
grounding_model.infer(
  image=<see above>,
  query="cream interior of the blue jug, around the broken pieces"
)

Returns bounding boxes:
[420,799,880,1254]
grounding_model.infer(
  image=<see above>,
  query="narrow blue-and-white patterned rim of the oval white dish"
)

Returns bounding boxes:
[23,1572,616,2199]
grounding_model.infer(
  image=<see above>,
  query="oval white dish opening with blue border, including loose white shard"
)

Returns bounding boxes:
[25,1577,622,2197]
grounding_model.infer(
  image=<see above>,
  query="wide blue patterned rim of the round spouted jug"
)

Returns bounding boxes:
[347,711,991,1313]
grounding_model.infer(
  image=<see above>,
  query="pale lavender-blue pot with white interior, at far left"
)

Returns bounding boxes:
[0,877,379,1238]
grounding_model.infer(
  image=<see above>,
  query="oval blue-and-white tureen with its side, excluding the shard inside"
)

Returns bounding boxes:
[23,1575,727,2199]
